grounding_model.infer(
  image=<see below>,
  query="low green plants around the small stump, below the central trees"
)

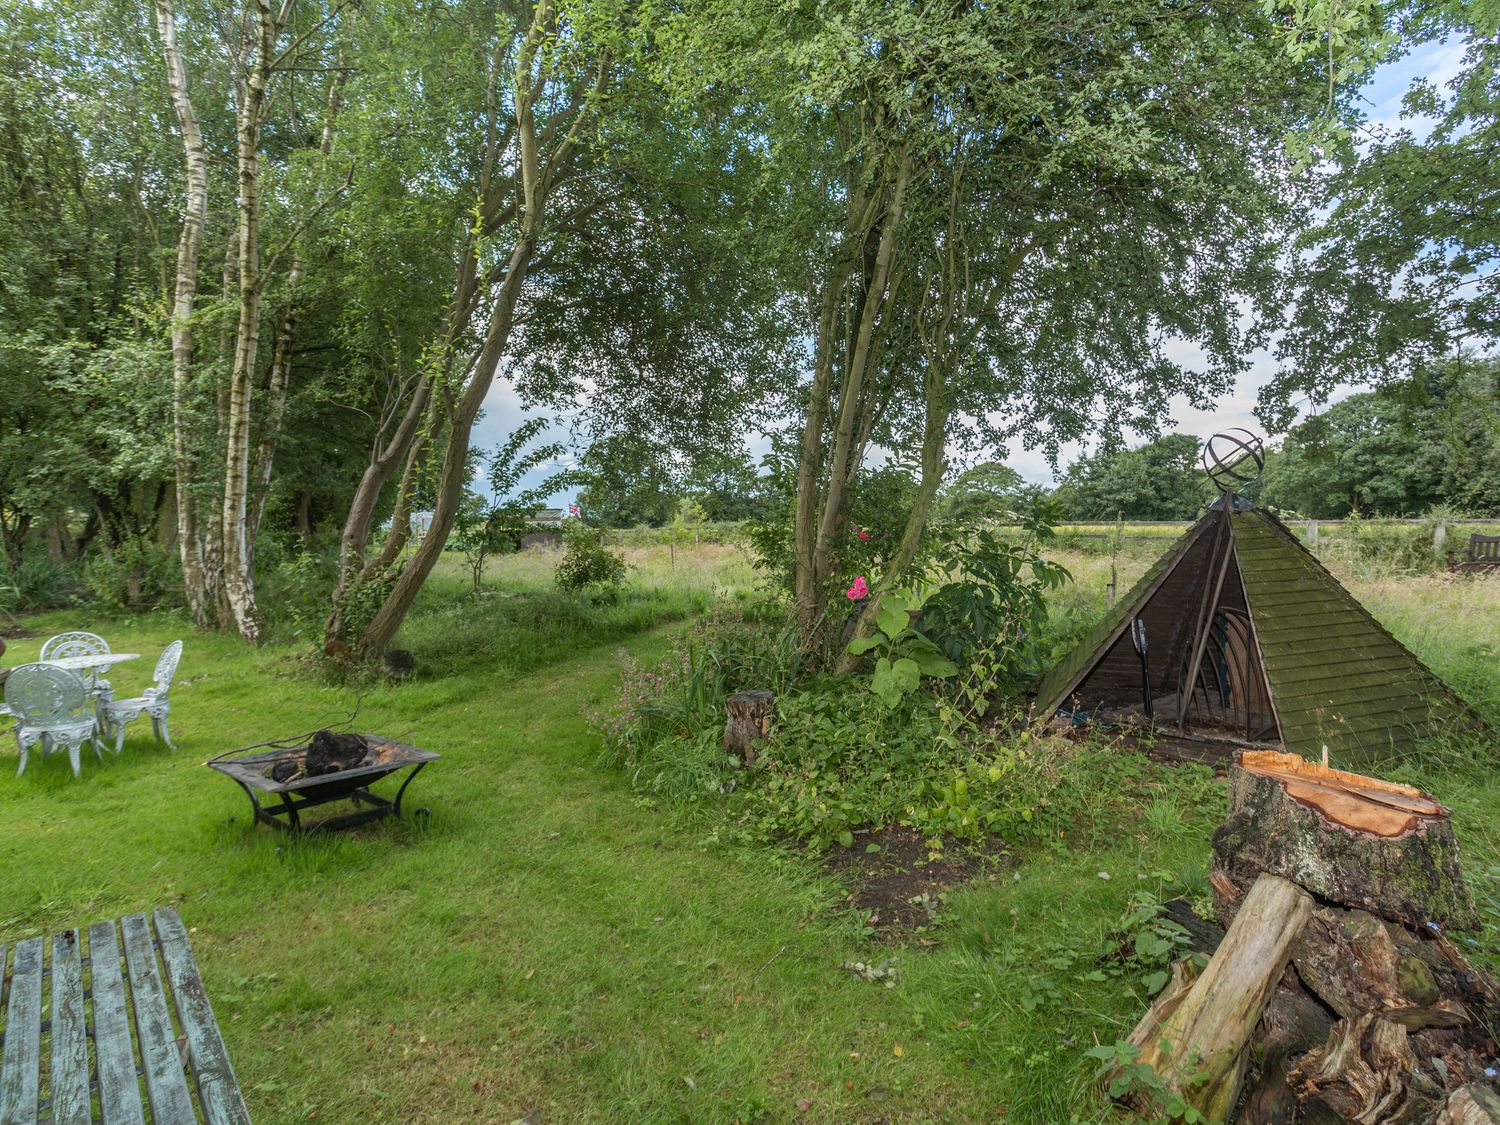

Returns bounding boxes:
[590,618,1215,851]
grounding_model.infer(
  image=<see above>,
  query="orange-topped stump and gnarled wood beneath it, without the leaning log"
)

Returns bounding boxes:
[1211,752,1500,1125]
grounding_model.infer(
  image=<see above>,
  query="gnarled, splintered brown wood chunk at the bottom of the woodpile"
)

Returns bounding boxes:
[1287,1013,1443,1125]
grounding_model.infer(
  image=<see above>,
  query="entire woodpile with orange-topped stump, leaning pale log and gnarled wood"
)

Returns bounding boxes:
[1110,752,1500,1125]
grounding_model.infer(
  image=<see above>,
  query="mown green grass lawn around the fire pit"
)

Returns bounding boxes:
[0,548,1500,1122]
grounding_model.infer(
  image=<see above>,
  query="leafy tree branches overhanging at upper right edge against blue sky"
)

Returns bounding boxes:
[1260,0,1500,428]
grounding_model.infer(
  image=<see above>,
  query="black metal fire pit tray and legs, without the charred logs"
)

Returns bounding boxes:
[206,735,438,831]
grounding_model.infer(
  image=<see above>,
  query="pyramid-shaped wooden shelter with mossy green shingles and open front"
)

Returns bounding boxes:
[1035,504,1479,762]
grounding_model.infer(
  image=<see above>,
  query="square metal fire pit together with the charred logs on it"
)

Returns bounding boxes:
[206,731,438,831]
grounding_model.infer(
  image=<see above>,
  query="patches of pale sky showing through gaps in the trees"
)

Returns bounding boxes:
[474,35,1463,506]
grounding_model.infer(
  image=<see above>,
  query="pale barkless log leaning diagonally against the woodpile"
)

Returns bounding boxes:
[1131,875,1313,1121]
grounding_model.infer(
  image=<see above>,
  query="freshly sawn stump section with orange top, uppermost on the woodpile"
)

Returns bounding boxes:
[1214,750,1479,930]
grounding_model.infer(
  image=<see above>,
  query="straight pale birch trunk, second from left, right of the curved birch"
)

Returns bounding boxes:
[222,0,281,644]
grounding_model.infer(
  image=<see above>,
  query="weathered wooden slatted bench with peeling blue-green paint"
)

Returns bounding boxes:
[0,908,251,1125]
